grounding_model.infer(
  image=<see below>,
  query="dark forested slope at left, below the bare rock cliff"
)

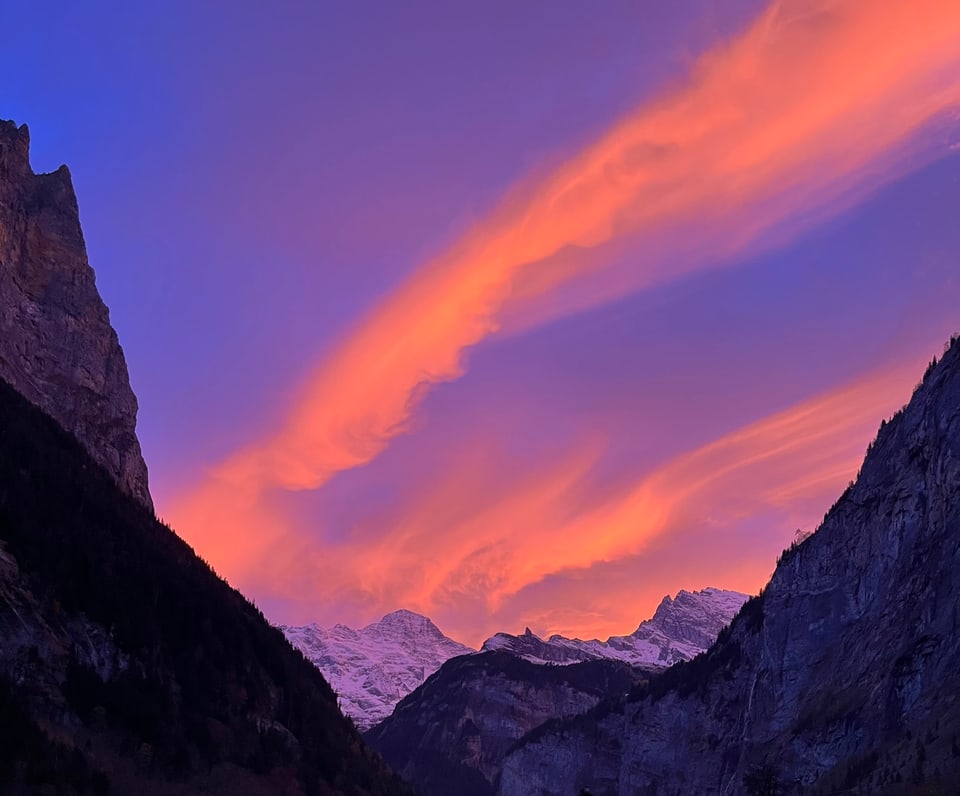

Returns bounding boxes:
[0,382,408,795]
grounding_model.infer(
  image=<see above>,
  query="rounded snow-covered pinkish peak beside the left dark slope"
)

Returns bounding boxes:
[280,610,476,729]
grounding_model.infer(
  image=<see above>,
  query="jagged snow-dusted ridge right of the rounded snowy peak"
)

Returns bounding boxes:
[482,588,747,669]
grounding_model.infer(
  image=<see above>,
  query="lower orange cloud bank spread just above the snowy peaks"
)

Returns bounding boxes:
[184,354,918,643]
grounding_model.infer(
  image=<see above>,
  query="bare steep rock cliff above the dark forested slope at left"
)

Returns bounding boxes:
[0,121,152,508]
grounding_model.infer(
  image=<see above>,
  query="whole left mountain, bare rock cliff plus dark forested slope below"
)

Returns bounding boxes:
[0,123,409,796]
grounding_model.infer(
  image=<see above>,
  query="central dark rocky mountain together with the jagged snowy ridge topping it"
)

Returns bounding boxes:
[365,589,747,796]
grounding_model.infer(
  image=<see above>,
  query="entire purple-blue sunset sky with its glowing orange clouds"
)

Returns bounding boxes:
[0,0,960,646]
